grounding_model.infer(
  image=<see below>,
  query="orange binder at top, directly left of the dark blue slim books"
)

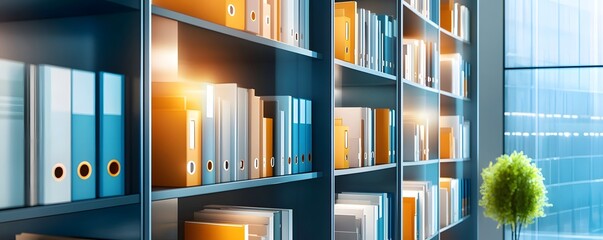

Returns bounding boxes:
[335,1,357,64]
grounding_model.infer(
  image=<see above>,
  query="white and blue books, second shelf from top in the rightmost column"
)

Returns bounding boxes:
[440,53,471,97]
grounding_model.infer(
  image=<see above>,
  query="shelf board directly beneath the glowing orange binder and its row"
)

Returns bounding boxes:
[152,172,322,201]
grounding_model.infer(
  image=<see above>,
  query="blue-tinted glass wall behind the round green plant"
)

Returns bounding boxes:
[504,0,603,240]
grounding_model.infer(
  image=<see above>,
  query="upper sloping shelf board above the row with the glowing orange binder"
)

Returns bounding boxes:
[151,5,322,59]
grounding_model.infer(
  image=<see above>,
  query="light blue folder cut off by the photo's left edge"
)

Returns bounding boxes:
[0,59,25,208]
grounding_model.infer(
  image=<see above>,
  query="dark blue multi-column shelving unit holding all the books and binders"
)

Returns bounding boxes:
[0,0,477,239]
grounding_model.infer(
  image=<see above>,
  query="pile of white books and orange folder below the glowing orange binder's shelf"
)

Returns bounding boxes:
[184,205,293,240]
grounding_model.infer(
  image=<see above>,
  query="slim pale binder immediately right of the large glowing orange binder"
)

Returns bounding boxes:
[201,85,217,185]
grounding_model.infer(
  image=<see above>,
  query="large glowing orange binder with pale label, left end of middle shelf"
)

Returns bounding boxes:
[152,97,201,187]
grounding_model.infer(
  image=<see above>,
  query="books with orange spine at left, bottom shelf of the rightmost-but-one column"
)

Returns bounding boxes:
[402,180,438,240]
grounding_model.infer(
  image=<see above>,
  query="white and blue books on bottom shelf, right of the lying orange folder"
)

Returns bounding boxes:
[335,192,393,240]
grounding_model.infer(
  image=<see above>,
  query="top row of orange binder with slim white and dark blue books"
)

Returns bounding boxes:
[334,1,398,75]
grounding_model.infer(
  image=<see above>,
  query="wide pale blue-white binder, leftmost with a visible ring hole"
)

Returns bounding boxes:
[35,65,71,204]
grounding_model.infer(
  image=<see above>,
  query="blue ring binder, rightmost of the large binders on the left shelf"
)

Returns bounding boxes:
[97,72,125,197]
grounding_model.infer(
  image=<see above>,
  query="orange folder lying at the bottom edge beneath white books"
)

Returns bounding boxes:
[184,221,249,240]
